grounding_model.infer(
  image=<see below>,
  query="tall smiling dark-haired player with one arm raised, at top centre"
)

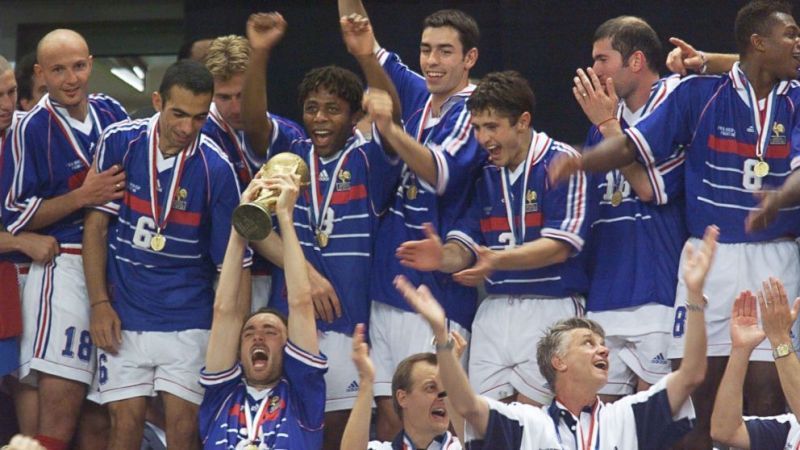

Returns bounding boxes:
[339,0,485,440]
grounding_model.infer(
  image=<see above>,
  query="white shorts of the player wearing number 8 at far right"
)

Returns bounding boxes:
[669,238,800,361]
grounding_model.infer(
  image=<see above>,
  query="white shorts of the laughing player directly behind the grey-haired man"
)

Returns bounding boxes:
[469,295,584,404]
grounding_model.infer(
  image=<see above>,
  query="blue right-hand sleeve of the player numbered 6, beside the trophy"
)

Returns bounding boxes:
[209,150,253,270]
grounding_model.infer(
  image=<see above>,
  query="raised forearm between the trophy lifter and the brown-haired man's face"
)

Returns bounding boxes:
[339,323,375,450]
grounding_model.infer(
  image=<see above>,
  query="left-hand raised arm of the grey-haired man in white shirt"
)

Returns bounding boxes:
[395,276,489,439]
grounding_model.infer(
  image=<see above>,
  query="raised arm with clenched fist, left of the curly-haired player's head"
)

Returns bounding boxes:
[242,13,286,159]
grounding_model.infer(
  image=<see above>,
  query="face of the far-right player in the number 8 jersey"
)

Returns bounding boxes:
[762,13,800,80]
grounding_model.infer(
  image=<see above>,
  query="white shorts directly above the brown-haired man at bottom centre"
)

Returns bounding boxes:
[369,301,470,397]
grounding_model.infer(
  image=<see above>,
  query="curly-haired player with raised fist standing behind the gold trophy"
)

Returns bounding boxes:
[234,13,400,448]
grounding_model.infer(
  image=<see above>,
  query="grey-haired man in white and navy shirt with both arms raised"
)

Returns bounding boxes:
[396,226,719,450]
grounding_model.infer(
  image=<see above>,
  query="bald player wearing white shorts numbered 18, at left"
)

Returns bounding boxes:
[2,29,128,449]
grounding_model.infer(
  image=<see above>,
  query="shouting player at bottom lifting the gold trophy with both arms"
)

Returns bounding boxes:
[200,175,328,450]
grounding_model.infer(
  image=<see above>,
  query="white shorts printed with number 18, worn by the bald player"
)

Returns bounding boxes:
[19,247,95,385]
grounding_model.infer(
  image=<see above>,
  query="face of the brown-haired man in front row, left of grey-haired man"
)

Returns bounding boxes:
[395,361,450,436]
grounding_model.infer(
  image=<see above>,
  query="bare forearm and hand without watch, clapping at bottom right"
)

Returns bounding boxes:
[711,291,764,449]
